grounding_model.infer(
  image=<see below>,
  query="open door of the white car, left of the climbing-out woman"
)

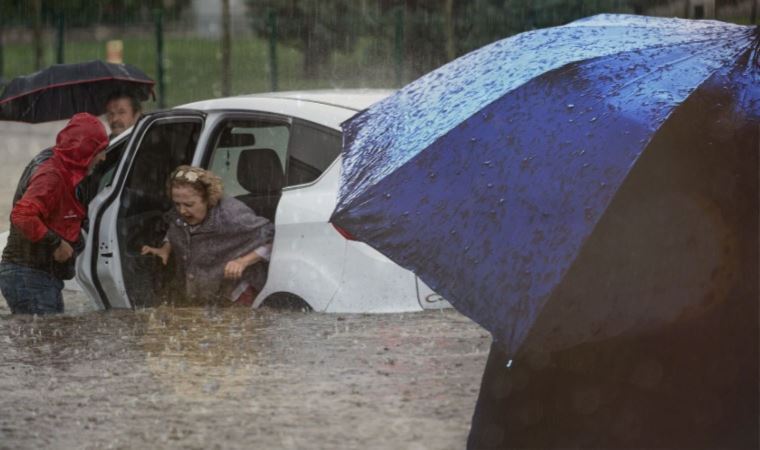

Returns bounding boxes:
[78,110,205,308]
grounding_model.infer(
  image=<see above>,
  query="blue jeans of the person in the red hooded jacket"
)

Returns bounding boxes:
[0,262,63,315]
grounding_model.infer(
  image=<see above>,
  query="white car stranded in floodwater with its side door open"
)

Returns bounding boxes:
[71,90,449,313]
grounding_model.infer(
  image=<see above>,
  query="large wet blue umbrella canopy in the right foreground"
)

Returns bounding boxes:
[332,15,760,354]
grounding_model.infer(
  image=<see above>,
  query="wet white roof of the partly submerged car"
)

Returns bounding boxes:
[177,89,394,128]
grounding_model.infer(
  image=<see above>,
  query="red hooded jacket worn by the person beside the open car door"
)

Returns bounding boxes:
[11,113,108,243]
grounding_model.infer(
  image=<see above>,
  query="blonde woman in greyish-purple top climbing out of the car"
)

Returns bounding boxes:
[142,166,274,305]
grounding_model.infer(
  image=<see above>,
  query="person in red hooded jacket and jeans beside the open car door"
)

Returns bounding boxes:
[0,113,108,314]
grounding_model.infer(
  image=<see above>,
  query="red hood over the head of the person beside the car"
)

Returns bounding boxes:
[53,113,108,184]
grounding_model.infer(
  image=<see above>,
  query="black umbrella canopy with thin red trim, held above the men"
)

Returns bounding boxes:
[0,61,155,123]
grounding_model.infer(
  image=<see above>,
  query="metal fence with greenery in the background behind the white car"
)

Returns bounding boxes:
[0,0,755,109]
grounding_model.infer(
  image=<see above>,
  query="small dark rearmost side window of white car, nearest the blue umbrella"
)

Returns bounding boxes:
[286,122,341,186]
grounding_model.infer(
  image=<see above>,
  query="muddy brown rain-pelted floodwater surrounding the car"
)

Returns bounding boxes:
[0,302,490,449]
